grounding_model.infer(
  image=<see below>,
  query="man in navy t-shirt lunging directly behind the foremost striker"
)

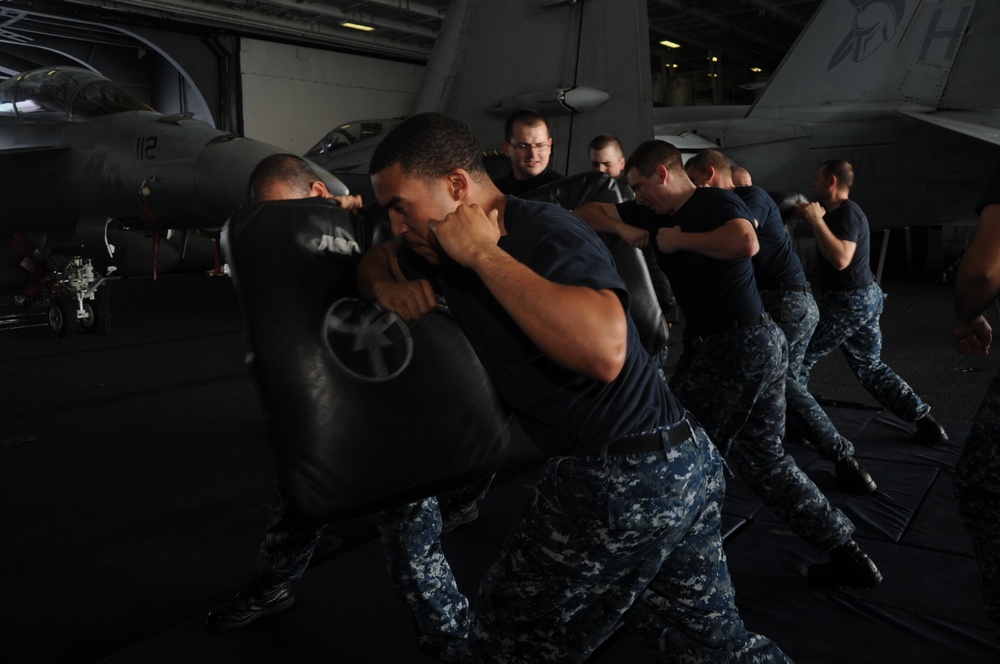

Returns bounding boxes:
[577,140,882,588]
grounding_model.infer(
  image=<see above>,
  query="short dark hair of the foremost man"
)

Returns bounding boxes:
[368,113,489,181]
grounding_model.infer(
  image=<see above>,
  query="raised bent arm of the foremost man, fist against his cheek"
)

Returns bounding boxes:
[431,205,628,382]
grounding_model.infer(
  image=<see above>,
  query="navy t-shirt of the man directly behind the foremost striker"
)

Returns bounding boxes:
[617,187,764,336]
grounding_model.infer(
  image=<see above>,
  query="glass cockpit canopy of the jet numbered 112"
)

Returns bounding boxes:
[0,67,152,119]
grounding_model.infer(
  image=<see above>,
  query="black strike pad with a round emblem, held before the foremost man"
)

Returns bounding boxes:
[227,199,508,520]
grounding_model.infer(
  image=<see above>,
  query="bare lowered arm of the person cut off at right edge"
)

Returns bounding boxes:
[952,205,1000,355]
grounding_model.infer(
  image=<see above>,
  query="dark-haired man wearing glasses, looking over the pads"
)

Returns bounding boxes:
[496,110,563,196]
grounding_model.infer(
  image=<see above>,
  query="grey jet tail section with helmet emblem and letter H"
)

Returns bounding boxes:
[654,0,1000,235]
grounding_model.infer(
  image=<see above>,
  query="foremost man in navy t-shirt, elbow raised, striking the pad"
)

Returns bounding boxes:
[358,113,786,662]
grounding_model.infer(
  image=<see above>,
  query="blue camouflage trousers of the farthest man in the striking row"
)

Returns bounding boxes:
[803,282,931,422]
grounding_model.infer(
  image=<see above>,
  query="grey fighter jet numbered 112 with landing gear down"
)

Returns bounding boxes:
[0,67,347,336]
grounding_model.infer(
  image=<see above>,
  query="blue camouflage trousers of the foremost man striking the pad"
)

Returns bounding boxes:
[466,428,776,664]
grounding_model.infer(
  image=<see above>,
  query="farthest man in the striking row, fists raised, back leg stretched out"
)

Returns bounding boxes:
[799,160,948,445]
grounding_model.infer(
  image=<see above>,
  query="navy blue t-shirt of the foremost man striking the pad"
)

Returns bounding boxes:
[401,196,684,456]
